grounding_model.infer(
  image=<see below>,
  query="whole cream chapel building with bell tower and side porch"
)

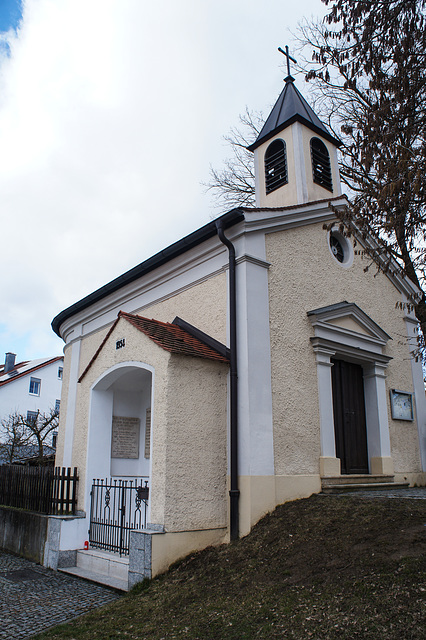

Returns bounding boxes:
[52,67,426,585]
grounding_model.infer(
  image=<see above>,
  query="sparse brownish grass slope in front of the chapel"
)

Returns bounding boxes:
[37,496,426,640]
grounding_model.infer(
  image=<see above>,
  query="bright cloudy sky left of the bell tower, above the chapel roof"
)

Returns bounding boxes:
[0,0,325,362]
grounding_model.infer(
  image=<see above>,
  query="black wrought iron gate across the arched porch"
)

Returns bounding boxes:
[89,477,149,556]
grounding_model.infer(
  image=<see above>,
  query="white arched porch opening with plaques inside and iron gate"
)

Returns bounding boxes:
[86,362,153,554]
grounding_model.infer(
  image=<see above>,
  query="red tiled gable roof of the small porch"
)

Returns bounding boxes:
[78,311,229,382]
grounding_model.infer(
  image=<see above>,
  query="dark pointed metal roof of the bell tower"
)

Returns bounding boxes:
[247,76,342,151]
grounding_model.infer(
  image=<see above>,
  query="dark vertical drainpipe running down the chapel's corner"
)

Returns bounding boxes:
[216,219,240,540]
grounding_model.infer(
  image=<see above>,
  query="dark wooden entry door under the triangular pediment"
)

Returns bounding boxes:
[331,360,368,473]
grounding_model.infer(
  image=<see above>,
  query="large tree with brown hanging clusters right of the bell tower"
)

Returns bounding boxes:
[300,0,426,344]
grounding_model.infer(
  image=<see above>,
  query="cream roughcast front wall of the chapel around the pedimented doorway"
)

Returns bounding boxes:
[266,224,421,475]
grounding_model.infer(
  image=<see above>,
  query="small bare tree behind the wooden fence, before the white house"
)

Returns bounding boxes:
[0,409,59,464]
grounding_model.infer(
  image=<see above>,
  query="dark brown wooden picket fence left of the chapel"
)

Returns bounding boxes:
[0,465,78,515]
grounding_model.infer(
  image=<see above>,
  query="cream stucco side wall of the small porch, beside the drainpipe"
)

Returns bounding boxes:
[160,355,228,531]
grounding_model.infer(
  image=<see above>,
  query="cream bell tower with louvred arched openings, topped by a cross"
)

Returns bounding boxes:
[248,47,341,207]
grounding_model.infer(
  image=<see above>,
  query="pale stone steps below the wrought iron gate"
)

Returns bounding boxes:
[61,549,129,591]
